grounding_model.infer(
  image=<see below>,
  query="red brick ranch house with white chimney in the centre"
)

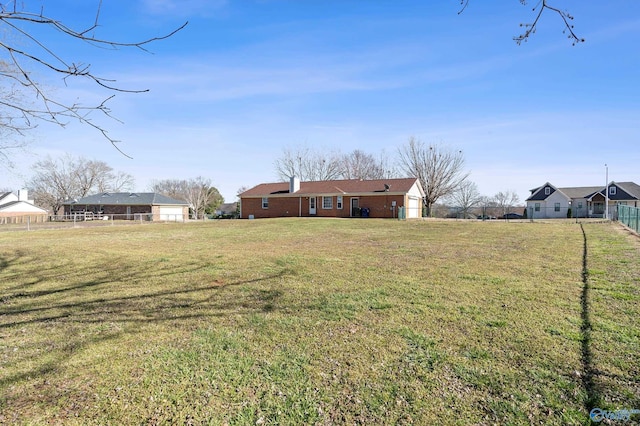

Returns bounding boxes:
[239,177,424,219]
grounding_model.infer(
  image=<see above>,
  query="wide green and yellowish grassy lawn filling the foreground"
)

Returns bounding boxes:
[0,219,640,425]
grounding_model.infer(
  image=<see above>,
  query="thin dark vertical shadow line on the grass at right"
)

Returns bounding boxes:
[580,224,600,412]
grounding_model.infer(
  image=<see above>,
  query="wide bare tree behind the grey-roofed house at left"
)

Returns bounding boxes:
[28,155,134,214]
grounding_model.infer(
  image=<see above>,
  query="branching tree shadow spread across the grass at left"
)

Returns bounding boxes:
[0,252,291,392]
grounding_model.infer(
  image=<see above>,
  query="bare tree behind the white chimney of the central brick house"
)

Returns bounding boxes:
[275,147,341,181]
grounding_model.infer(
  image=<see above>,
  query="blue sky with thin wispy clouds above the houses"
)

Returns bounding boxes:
[0,0,640,201]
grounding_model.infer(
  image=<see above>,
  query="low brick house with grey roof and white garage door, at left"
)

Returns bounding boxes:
[63,192,189,222]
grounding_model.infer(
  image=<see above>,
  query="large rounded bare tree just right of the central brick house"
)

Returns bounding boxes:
[398,137,469,216]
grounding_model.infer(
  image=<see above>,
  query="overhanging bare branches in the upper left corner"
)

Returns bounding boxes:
[0,0,187,155]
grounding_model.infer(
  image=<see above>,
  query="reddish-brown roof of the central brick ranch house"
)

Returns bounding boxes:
[240,178,423,198]
